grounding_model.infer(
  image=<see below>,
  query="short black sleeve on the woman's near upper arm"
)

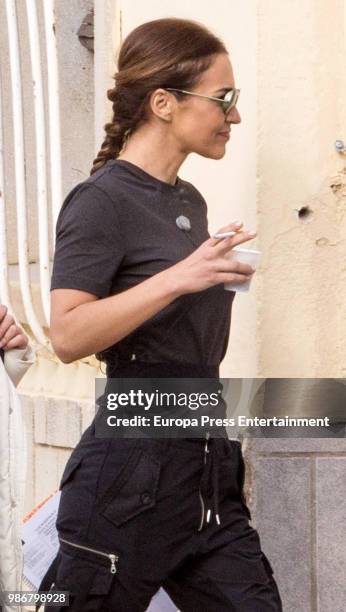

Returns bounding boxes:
[51,183,125,298]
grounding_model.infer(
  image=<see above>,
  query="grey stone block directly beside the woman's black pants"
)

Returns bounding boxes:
[252,457,311,612]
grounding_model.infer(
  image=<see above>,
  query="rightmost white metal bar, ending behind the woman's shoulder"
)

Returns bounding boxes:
[43,0,62,236]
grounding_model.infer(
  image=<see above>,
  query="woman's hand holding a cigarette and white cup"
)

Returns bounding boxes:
[166,223,256,295]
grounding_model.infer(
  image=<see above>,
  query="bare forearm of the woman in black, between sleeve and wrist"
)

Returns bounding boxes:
[51,271,179,363]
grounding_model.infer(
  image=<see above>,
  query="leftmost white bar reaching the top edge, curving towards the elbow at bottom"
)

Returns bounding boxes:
[6,0,48,345]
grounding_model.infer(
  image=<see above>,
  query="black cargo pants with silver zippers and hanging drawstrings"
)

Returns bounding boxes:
[45,425,282,612]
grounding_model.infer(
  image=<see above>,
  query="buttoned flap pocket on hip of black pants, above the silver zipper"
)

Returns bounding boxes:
[99,448,161,527]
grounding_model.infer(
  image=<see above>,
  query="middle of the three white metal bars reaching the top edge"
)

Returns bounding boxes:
[26,0,50,324]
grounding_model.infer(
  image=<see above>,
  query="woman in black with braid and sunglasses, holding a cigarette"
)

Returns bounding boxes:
[46,19,281,612]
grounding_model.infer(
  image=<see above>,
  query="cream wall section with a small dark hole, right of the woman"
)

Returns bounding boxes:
[257,0,346,377]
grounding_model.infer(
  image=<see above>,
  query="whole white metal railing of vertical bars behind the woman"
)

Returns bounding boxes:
[0,0,62,347]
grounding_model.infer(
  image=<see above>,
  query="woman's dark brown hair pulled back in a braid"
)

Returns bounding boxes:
[91,18,227,174]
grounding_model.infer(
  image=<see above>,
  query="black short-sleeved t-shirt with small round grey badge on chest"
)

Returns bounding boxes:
[51,160,235,366]
